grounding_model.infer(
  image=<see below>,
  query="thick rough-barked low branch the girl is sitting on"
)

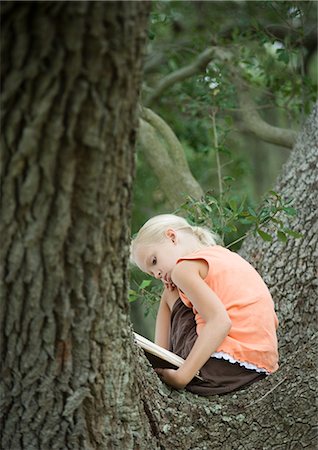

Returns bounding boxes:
[137,330,317,450]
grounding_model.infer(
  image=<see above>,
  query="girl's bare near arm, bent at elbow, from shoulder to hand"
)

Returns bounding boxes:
[157,261,231,389]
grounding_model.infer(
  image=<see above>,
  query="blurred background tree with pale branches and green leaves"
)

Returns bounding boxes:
[133,1,317,216]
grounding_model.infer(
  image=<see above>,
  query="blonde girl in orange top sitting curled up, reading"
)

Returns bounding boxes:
[131,214,278,395]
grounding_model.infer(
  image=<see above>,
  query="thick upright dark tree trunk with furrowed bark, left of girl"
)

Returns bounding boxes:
[0,2,149,450]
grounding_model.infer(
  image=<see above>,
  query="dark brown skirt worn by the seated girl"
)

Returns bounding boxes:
[170,298,266,396]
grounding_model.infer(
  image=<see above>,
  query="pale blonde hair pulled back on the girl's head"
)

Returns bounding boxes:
[131,214,220,260]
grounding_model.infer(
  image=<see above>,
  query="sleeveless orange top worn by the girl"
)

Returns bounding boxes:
[177,245,278,373]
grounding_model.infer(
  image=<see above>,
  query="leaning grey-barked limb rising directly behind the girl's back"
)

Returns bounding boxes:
[241,104,318,359]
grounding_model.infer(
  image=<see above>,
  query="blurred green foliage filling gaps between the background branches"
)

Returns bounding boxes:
[133,1,317,229]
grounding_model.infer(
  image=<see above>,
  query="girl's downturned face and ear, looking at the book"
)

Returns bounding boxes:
[135,230,187,283]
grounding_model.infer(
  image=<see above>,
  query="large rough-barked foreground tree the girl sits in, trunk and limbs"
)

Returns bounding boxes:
[0,2,317,450]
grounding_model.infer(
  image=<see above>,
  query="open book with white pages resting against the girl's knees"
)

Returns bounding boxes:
[134,332,202,380]
